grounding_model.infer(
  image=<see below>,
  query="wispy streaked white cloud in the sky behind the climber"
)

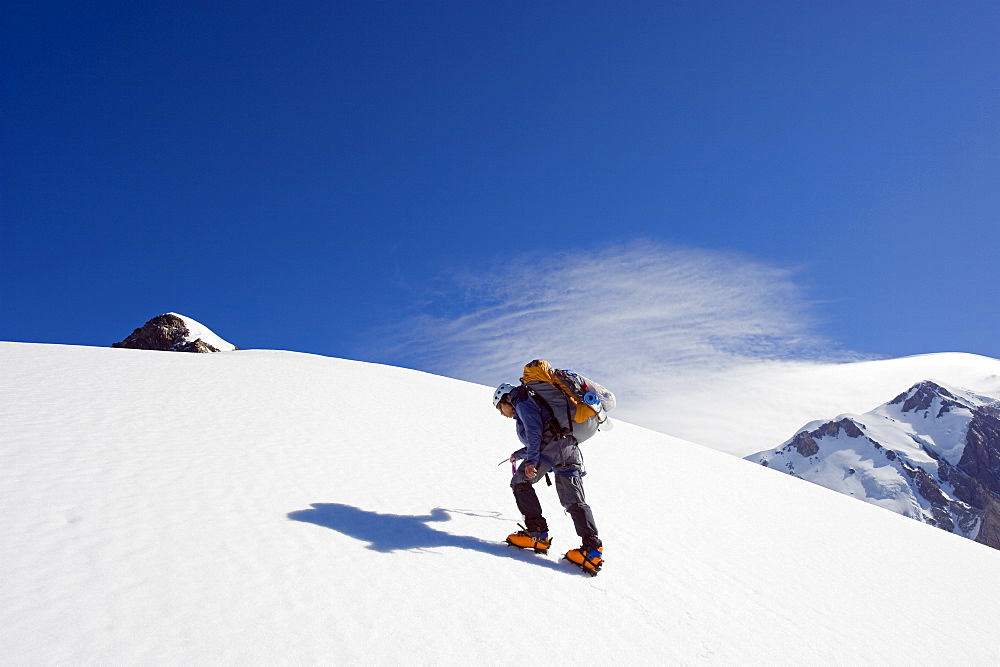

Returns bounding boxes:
[372,243,856,448]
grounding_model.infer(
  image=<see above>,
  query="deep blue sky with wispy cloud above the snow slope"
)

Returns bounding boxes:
[0,1,1000,381]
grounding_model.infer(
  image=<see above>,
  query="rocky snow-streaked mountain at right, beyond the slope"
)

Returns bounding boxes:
[746,381,1000,549]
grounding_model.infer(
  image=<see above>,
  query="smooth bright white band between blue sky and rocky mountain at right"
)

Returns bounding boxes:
[636,352,1000,457]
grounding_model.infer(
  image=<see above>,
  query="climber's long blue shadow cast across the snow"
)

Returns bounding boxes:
[288,503,566,572]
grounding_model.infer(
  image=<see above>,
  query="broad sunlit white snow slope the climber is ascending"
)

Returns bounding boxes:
[0,343,1000,665]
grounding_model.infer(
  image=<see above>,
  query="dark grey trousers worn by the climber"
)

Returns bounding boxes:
[510,461,601,549]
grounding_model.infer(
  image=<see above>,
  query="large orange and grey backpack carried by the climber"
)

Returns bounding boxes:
[521,359,615,442]
